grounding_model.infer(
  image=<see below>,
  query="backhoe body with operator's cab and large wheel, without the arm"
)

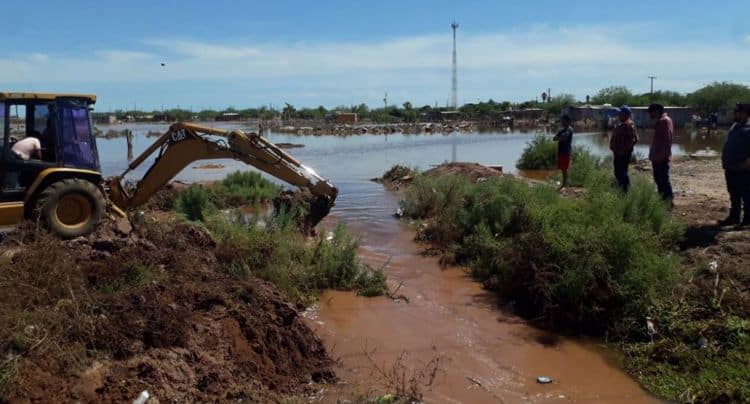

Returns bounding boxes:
[0,92,103,237]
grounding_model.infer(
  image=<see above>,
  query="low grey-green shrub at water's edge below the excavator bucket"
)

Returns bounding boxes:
[207,214,386,302]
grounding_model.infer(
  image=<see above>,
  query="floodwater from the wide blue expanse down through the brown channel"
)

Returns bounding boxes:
[97,125,723,403]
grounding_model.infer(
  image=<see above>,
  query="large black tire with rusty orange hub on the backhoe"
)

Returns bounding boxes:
[35,178,104,238]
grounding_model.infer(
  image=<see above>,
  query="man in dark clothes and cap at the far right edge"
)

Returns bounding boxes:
[719,104,750,226]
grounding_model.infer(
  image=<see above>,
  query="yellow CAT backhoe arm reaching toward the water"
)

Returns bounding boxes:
[107,123,338,223]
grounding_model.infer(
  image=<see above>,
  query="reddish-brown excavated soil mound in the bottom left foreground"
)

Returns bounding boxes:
[0,220,335,402]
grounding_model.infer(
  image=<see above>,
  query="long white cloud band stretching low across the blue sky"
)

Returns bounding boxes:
[0,26,750,104]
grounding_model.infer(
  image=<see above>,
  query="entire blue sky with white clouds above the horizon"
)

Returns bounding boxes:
[0,0,750,111]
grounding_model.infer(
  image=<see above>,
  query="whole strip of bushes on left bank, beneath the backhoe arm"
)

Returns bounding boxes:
[175,174,386,304]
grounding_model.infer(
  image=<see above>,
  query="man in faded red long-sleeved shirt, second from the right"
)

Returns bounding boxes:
[648,104,674,208]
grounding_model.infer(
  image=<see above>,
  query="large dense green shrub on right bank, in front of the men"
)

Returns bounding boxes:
[403,169,683,336]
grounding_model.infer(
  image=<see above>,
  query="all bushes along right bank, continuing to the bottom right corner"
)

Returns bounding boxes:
[394,163,750,402]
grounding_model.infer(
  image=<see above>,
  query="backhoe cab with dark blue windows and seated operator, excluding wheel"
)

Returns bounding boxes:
[0,93,99,201]
